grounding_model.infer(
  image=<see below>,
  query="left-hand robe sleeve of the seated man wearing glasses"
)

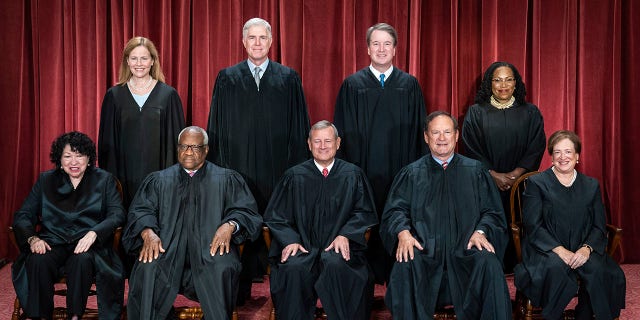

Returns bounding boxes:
[122,174,160,255]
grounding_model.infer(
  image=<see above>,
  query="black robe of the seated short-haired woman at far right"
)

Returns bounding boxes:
[515,169,626,319]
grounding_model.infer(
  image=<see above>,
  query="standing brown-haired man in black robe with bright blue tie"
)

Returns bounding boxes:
[334,23,426,283]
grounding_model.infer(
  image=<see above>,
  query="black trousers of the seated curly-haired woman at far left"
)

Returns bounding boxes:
[23,244,94,319]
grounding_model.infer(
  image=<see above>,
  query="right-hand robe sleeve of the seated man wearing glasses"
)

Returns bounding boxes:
[224,172,262,244]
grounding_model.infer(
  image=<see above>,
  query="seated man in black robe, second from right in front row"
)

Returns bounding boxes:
[380,111,511,320]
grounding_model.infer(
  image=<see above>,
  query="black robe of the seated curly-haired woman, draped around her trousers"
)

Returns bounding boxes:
[11,167,125,319]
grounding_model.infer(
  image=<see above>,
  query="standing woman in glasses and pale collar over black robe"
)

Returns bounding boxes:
[462,62,545,272]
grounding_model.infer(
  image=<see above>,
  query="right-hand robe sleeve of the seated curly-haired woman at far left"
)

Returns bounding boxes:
[91,174,125,246]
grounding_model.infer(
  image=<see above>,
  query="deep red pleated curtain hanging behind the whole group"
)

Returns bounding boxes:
[0,0,640,263]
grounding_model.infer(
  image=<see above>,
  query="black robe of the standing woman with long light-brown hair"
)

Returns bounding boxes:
[98,82,185,208]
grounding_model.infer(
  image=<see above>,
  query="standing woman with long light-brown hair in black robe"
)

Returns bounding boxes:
[98,37,185,208]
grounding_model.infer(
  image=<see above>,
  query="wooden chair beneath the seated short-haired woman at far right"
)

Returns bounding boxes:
[510,171,622,320]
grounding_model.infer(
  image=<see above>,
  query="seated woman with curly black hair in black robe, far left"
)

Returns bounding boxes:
[12,131,125,319]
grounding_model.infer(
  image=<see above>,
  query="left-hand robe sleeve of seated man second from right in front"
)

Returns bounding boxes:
[380,167,413,255]
